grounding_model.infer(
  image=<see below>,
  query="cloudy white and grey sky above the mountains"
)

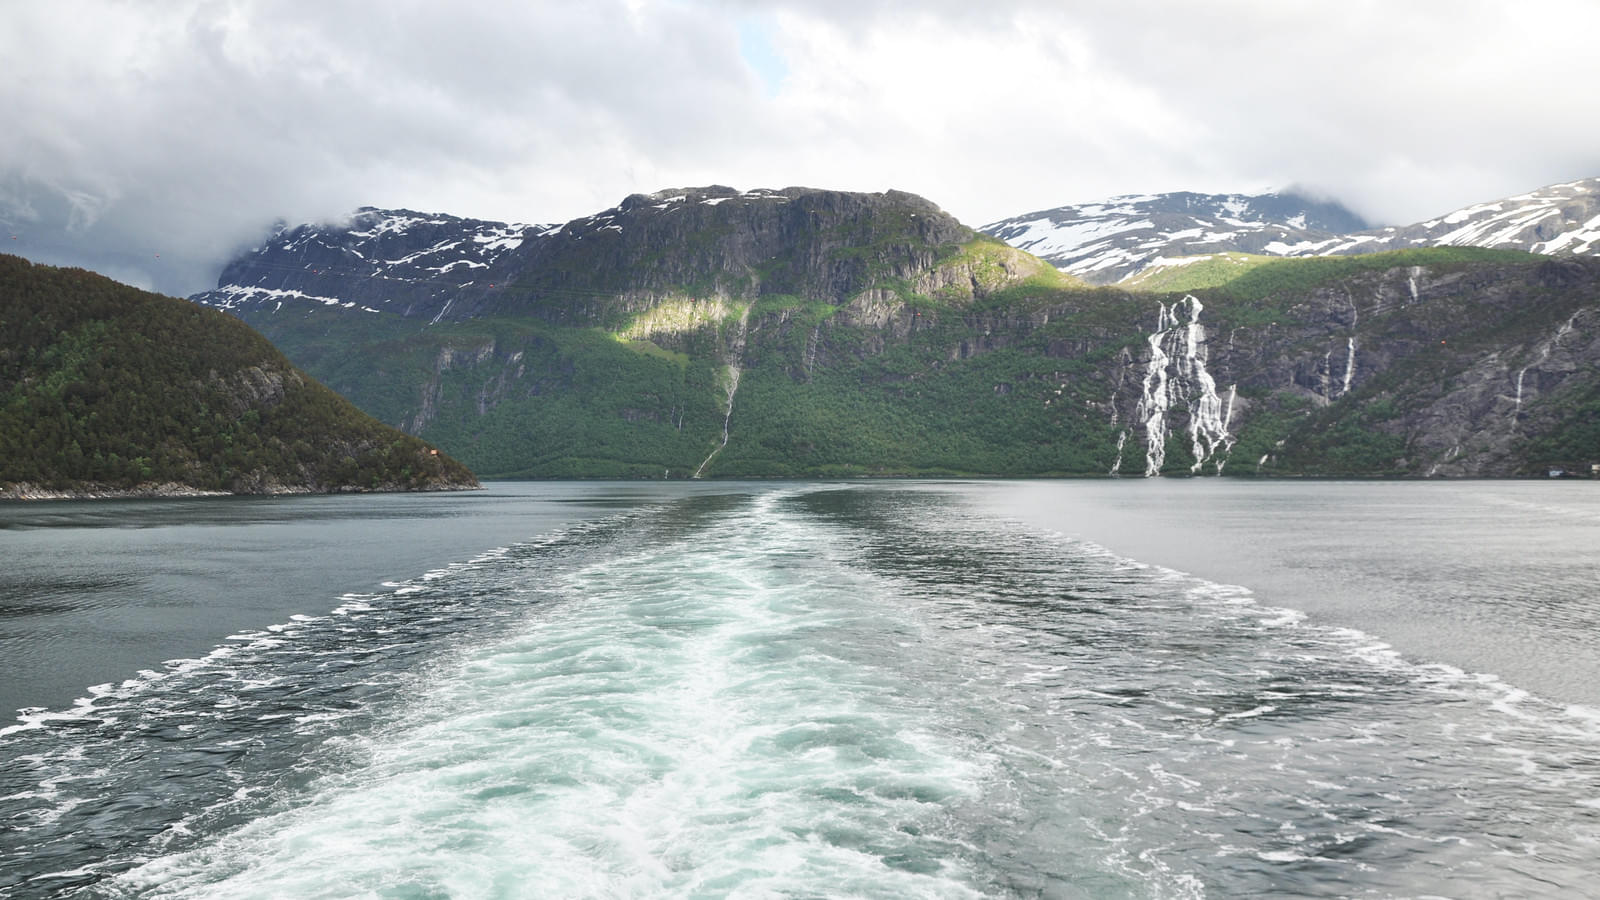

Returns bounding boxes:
[0,0,1600,296]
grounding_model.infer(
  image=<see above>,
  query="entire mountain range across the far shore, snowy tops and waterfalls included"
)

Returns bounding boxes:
[181,181,1600,477]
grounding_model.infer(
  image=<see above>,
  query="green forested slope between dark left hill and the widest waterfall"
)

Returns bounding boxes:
[240,267,1136,477]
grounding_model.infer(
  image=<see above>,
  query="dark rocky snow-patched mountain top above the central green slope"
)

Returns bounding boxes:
[195,184,978,322]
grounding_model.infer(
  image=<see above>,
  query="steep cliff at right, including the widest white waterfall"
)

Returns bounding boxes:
[1115,258,1600,477]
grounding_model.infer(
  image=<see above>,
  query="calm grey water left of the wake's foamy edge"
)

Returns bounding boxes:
[0,482,713,717]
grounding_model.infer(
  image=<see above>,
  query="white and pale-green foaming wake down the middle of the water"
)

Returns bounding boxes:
[112,496,989,898]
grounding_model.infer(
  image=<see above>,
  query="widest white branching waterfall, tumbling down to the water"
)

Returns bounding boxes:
[1112,295,1237,477]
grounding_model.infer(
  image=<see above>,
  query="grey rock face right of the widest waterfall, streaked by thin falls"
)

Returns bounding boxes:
[1114,259,1600,477]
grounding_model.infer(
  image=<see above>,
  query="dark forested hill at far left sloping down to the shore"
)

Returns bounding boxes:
[0,256,475,493]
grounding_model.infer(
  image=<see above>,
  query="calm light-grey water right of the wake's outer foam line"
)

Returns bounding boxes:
[957,479,1600,709]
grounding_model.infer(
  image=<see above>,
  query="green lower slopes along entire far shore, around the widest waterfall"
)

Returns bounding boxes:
[240,248,1600,477]
